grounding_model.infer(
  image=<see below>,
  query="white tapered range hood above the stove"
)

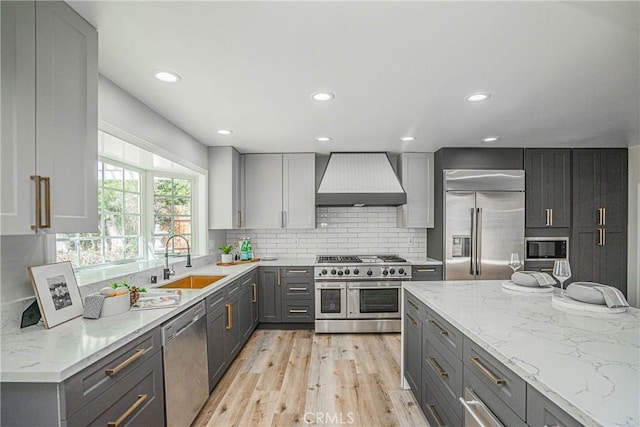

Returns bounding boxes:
[316,153,407,206]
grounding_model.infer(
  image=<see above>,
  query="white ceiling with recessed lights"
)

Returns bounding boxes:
[69,1,640,153]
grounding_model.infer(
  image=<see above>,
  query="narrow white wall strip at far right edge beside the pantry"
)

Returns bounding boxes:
[627,145,640,307]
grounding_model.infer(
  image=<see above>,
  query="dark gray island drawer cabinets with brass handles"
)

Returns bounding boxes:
[403,291,580,427]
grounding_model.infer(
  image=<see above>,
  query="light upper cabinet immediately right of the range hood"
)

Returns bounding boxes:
[397,153,433,228]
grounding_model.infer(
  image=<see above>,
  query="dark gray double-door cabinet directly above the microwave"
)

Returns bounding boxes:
[524,148,571,228]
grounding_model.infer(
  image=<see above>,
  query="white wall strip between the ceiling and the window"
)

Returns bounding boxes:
[98,75,207,170]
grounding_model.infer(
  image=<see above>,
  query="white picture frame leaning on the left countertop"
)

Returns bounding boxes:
[28,261,84,329]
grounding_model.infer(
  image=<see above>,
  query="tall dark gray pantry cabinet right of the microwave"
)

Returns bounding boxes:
[569,148,628,295]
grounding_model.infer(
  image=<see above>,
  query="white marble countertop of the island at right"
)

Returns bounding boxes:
[404,281,640,426]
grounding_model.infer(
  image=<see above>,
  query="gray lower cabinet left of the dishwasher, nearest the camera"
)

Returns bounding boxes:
[1,328,165,426]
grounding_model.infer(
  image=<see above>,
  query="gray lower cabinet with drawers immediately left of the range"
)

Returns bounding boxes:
[258,267,315,323]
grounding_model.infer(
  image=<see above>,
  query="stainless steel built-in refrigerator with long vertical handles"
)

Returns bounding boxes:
[443,169,524,280]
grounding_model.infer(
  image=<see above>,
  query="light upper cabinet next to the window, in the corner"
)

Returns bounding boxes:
[208,147,245,230]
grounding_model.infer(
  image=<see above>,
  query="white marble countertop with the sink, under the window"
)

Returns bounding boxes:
[0,262,260,383]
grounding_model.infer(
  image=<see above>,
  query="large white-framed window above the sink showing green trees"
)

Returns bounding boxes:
[56,159,193,268]
